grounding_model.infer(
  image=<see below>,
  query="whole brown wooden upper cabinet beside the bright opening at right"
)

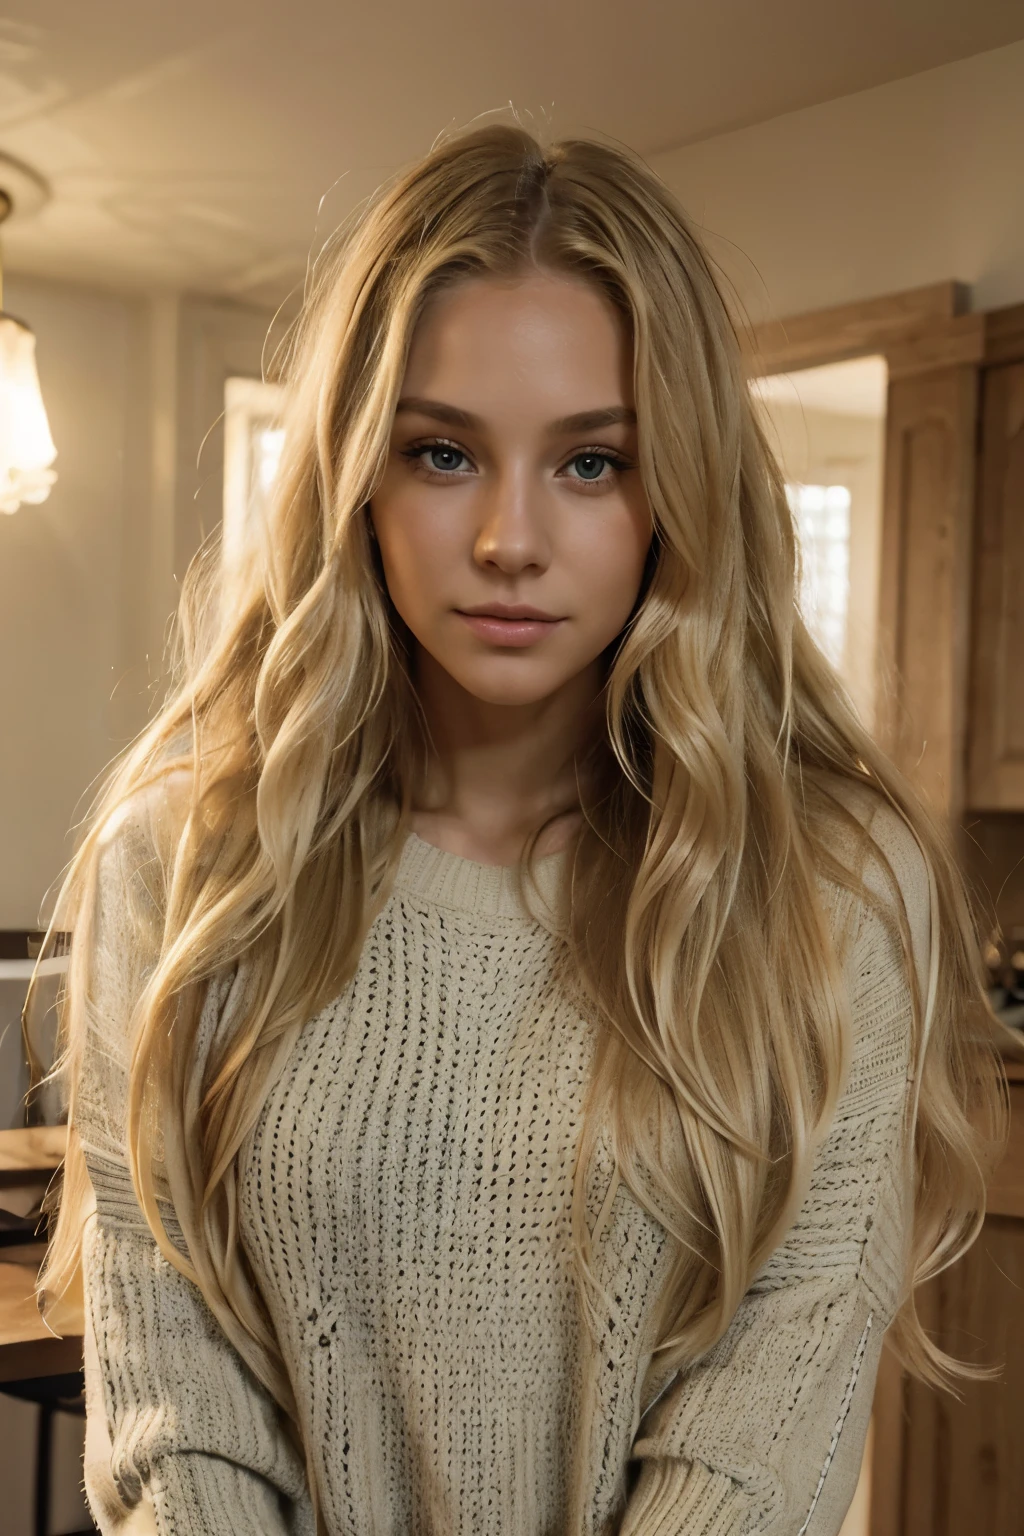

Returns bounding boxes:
[878,306,1024,826]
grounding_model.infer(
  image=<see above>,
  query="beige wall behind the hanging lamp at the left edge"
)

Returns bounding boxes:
[0,278,147,928]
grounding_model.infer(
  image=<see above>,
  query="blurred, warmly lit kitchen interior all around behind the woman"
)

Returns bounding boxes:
[0,0,1024,1536]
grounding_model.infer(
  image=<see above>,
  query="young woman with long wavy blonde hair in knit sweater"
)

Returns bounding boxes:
[33,126,999,1536]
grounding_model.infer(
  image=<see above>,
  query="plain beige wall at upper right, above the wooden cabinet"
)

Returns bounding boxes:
[652,43,1024,321]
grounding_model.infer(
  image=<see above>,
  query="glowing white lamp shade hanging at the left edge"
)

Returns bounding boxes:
[0,313,57,511]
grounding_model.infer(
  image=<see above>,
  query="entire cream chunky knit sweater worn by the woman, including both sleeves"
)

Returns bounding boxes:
[78,806,930,1536]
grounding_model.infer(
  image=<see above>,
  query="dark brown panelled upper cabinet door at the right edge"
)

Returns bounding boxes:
[967,362,1024,811]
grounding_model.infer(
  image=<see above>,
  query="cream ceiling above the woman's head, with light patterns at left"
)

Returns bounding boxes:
[0,0,1024,311]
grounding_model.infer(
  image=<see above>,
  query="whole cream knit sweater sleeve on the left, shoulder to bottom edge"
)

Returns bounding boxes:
[75,820,313,1536]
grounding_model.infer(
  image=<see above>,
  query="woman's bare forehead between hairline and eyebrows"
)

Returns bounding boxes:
[404,272,633,416]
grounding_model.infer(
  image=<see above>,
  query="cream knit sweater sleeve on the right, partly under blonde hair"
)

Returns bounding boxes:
[619,808,930,1536]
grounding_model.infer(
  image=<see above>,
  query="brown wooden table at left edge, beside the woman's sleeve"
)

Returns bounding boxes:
[0,1126,83,1384]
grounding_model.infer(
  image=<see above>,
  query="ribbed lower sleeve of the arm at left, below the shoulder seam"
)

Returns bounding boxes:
[83,1164,312,1536]
